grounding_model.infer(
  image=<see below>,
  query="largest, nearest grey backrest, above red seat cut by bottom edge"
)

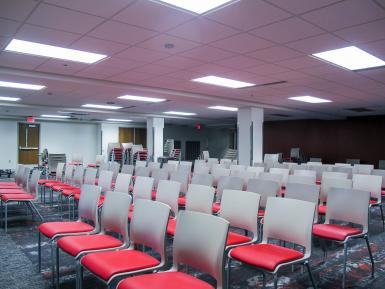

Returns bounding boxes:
[172,211,229,289]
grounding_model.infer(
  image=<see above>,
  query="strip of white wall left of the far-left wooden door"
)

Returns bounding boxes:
[0,120,18,169]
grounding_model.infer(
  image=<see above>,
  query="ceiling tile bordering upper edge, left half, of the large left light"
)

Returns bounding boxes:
[15,24,80,46]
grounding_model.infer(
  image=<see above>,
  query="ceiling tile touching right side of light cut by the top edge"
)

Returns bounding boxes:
[207,0,290,31]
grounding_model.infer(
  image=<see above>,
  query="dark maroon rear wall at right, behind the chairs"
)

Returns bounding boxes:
[264,117,385,165]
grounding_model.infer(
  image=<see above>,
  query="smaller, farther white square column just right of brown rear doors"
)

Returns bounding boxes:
[147,117,164,162]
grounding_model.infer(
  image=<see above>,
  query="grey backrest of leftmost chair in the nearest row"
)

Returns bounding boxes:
[78,184,101,228]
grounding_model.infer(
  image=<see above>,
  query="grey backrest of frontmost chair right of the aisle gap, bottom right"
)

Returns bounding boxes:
[262,198,315,257]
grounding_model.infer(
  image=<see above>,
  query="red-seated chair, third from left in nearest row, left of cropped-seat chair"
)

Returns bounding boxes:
[77,199,170,288]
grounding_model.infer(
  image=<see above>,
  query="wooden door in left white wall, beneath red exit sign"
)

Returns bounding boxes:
[19,123,40,165]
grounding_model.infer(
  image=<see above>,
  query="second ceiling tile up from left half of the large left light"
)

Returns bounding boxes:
[27,4,103,34]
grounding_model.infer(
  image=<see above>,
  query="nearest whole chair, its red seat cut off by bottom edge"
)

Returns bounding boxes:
[117,211,229,289]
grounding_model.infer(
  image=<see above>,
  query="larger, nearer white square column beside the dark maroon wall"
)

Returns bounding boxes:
[238,107,263,166]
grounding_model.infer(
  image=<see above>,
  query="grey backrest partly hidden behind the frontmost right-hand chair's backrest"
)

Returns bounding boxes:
[285,183,320,223]
